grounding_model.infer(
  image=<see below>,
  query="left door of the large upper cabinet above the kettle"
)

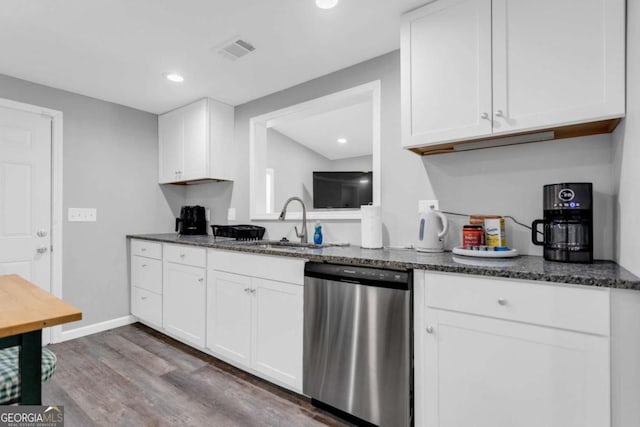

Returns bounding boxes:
[401,0,492,147]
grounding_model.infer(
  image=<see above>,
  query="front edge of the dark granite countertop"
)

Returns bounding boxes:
[126,234,640,291]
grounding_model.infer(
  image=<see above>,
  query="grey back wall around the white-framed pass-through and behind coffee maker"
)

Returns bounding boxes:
[187,51,616,259]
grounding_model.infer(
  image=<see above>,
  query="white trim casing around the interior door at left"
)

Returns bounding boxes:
[0,98,64,342]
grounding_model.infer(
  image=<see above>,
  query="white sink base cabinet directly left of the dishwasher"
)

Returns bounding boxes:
[206,250,305,392]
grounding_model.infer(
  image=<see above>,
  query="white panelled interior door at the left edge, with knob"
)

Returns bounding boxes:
[0,107,52,343]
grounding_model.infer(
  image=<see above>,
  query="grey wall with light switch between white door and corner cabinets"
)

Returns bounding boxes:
[0,75,184,330]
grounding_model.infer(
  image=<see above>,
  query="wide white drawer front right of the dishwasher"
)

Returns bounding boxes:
[424,272,610,335]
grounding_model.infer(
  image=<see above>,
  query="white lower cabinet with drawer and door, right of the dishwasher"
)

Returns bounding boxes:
[415,272,611,427]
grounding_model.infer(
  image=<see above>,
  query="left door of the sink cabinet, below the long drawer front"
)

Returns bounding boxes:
[207,270,251,367]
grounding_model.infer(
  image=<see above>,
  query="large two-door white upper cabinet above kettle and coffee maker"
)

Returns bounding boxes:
[401,0,625,152]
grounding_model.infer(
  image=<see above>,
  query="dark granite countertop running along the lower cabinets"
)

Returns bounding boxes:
[127,233,640,290]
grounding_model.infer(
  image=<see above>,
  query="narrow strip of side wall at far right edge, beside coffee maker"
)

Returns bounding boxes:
[613,1,640,276]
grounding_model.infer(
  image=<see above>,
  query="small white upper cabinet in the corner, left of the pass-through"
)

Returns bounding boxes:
[158,98,234,184]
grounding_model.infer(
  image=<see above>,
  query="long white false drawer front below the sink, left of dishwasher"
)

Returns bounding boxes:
[208,249,306,285]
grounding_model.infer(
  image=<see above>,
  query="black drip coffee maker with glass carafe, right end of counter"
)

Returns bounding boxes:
[531,182,593,262]
